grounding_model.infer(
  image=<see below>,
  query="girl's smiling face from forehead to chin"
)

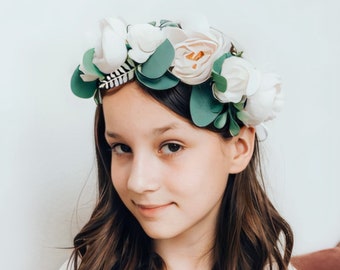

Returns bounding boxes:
[103,83,239,243]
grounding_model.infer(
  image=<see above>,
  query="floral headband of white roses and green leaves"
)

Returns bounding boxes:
[71,15,283,136]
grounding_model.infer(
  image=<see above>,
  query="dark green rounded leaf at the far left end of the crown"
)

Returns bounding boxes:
[71,66,97,98]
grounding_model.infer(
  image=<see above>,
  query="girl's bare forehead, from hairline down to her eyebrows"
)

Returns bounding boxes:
[103,83,219,143]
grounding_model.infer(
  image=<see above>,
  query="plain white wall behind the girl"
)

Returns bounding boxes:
[0,0,340,270]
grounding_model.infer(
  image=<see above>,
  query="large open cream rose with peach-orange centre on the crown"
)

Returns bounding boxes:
[167,16,231,85]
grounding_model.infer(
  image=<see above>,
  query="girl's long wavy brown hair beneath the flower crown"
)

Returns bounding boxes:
[72,83,293,270]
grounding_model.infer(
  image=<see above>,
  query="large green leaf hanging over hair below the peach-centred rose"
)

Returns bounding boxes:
[190,81,223,127]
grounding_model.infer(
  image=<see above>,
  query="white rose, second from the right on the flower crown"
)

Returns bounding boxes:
[213,56,262,103]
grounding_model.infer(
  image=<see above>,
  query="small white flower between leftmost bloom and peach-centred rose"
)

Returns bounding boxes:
[127,23,165,63]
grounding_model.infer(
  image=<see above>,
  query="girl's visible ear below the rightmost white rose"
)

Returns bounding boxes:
[230,126,255,174]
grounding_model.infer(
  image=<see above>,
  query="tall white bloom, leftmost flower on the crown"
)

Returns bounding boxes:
[93,18,127,74]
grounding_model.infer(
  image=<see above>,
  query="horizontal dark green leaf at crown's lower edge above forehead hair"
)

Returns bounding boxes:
[135,70,179,90]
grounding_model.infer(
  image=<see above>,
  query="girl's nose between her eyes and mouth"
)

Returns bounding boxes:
[128,154,161,193]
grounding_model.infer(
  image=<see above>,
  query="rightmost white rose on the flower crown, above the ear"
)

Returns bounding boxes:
[240,73,284,126]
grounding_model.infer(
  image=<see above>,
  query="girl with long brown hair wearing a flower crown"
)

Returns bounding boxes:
[65,15,293,270]
